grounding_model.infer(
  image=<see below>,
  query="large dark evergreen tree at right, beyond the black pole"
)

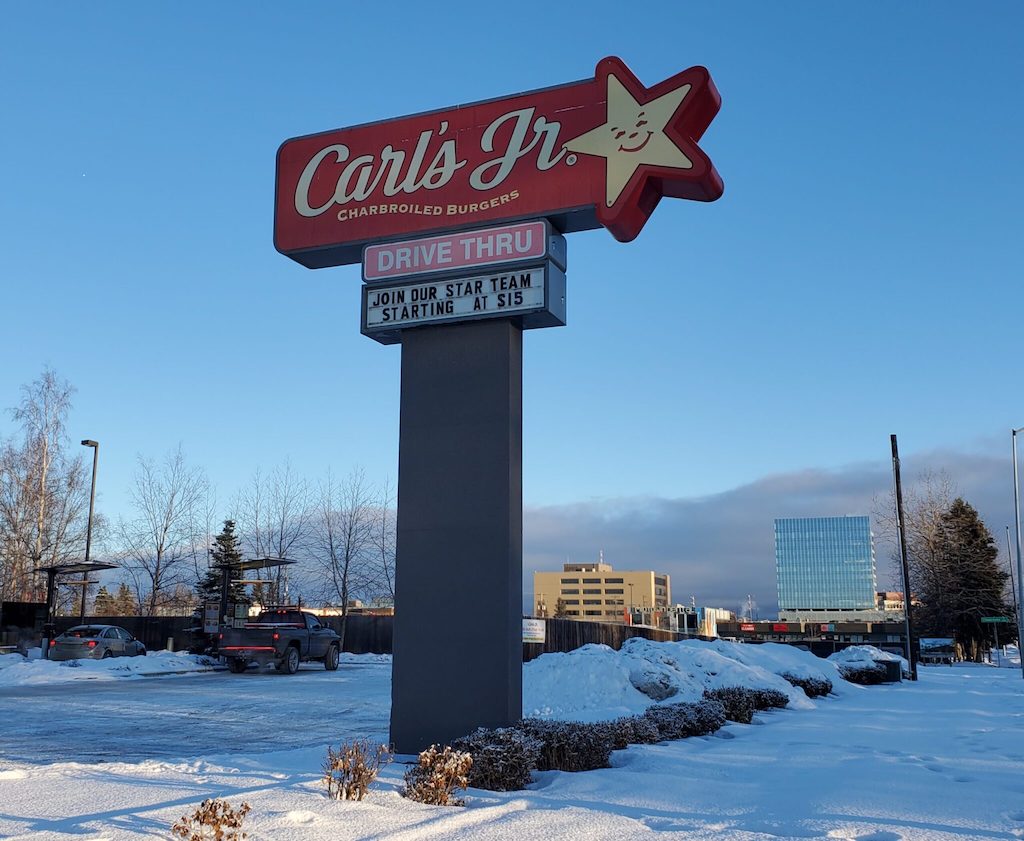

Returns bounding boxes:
[913,497,1011,661]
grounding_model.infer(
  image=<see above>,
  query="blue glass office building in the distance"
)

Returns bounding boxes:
[775,516,876,619]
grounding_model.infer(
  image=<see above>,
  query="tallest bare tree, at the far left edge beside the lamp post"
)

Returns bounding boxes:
[0,368,91,600]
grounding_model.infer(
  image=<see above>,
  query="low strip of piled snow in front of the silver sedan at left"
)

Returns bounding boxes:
[0,651,222,688]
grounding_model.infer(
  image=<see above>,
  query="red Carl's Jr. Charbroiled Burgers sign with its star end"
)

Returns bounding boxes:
[274,58,723,268]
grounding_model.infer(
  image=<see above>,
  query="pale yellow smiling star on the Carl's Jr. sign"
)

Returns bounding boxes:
[565,73,693,207]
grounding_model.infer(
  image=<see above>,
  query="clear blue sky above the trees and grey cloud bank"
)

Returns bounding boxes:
[0,2,1024,610]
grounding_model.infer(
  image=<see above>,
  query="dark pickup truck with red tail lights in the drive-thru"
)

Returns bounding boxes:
[217,607,341,675]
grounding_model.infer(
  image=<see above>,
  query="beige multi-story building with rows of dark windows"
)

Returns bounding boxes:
[534,562,672,625]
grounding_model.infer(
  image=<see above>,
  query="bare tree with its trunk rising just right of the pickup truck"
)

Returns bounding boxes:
[312,468,379,647]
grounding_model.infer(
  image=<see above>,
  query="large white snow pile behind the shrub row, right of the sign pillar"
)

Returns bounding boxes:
[522,637,846,721]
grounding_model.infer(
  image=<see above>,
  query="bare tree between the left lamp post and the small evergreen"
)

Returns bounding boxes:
[118,446,207,616]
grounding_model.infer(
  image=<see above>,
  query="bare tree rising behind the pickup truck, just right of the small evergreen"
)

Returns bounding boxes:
[236,462,310,603]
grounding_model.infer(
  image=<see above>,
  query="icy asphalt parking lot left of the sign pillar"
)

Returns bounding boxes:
[0,663,391,764]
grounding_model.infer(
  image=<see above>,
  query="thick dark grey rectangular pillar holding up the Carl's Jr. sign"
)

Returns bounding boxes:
[391,319,522,754]
